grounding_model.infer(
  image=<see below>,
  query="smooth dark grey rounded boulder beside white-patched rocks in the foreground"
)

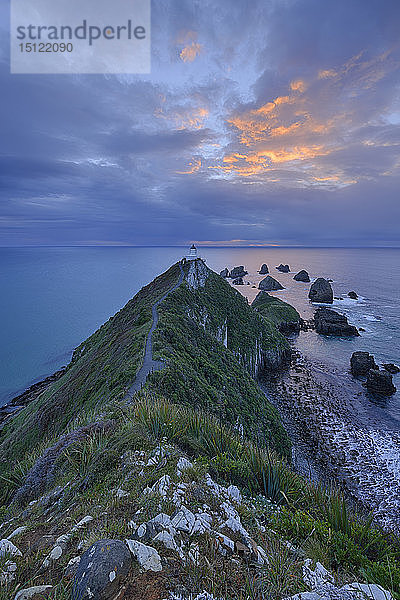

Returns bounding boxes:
[72,540,130,600]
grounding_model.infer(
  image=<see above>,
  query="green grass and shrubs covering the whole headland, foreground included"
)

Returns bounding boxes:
[0,265,400,600]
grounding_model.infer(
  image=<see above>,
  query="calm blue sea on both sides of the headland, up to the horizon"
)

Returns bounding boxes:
[0,247,400,419]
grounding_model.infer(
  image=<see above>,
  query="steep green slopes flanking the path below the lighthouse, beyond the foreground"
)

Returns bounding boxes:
[0,261,289,468]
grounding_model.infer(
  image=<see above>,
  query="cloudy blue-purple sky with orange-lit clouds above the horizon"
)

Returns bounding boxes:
[0,0,400,246]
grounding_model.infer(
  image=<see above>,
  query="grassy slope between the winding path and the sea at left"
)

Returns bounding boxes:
[0,265,180,469]
